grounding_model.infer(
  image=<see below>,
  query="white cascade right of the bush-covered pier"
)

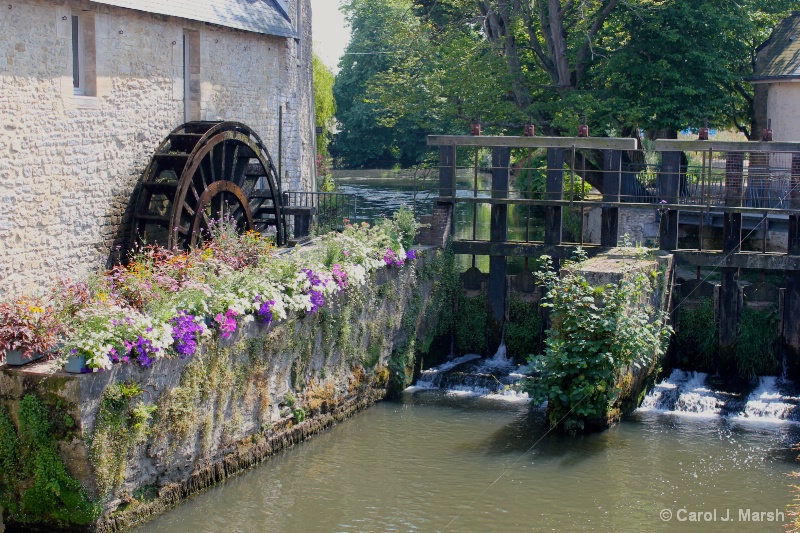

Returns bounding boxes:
[639,369,800,421]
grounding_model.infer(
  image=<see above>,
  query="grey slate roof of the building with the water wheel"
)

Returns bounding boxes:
[91,0,297,37]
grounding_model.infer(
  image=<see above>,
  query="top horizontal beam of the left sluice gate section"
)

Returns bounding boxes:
[428,135,637,150]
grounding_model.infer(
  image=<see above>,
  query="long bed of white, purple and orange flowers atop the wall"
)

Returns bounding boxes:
[0,212,416,372]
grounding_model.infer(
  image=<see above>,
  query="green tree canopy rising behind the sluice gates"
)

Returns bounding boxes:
[334,0,800,166]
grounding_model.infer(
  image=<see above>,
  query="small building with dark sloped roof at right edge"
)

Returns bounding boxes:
[750,11,800,141]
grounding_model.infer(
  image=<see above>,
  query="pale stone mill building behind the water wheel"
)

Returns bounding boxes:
[0,0,314,296]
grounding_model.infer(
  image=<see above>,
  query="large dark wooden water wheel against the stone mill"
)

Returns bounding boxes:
[131,122,286,249]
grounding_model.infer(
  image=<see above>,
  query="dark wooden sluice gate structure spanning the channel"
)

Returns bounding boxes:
[428,136,800,374]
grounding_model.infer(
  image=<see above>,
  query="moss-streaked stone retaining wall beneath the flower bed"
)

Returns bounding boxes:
[0,251,447,531]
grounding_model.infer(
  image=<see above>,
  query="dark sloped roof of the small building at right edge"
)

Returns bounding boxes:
[751,11,800,81]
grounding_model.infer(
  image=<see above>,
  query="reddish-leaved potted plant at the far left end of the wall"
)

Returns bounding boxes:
[0,298,61,358]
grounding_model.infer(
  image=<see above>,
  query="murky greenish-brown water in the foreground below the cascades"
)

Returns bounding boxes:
[137,382,800,533]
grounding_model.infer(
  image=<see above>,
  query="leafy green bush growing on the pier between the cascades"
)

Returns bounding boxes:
[528,252,671,432]
